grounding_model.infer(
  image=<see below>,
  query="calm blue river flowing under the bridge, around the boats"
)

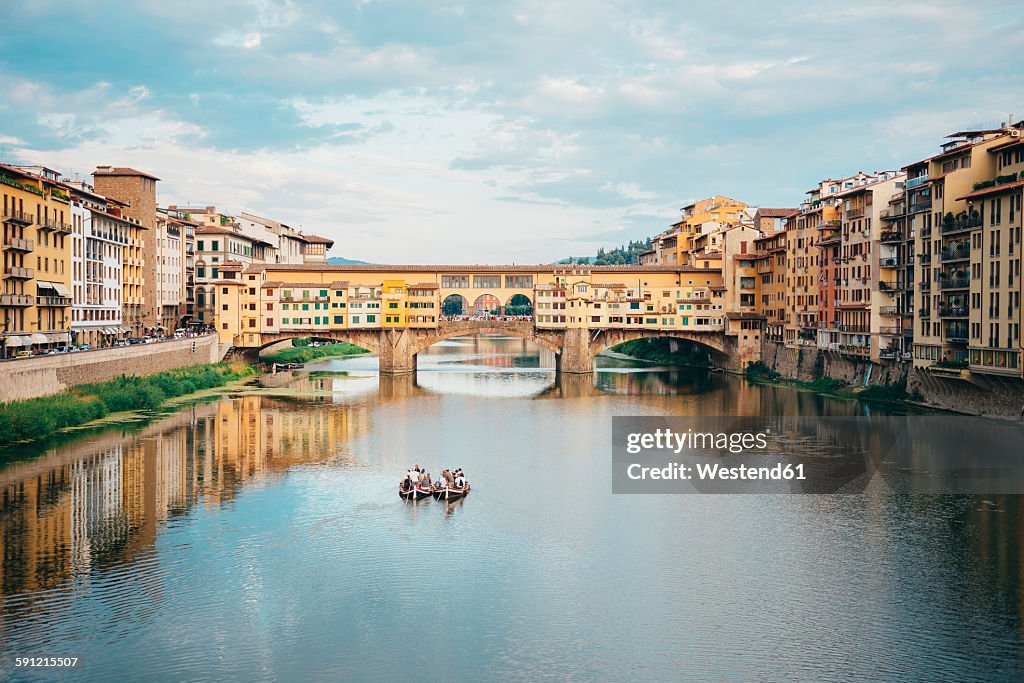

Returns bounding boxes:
[0,337,1024,681]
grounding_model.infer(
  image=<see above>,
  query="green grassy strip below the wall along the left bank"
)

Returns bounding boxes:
[0,362,256,445]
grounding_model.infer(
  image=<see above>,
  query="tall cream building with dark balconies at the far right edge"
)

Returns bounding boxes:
[904,124,1024,377]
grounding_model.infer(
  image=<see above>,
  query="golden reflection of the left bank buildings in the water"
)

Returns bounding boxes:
[0,396,370,595]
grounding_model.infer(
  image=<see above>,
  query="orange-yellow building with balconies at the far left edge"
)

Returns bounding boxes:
[0,164,72,357]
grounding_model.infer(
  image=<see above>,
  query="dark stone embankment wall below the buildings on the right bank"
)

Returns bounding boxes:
[761,341,1024,417]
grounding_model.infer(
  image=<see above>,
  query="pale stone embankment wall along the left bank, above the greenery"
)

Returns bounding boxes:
[0,335,223,401]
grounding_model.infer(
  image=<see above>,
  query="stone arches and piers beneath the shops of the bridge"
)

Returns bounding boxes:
[249,321,749,375]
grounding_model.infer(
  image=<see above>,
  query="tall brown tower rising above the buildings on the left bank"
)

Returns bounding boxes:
[92,166,160,337]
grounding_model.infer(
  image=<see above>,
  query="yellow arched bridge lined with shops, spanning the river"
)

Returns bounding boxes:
[216,263,762,374]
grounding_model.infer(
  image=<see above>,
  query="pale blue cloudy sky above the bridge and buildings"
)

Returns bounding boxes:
[0,0,1024,263]
